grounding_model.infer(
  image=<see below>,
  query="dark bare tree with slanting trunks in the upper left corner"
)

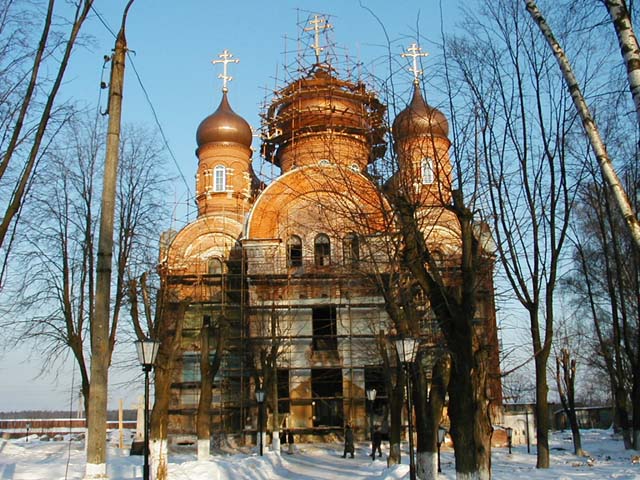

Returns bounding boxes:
[0,0,93,266]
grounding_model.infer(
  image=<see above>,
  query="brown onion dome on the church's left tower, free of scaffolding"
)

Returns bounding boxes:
[196,92,253,148]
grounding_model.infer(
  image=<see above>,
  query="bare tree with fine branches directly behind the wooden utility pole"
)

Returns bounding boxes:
[0,109,166,450]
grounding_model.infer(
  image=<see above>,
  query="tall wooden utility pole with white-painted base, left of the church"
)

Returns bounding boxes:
[84,0,134,479]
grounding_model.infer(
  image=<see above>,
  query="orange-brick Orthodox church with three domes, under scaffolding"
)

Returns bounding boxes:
[161,17,501,446]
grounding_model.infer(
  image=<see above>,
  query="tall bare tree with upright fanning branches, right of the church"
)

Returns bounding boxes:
[448,2,585,468]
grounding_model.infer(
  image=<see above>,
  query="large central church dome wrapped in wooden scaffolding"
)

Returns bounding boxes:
[262,64,386,171]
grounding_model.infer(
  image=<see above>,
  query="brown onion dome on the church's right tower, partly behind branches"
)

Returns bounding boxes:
[392,84,449,142]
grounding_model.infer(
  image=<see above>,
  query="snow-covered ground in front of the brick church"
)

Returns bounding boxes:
[0,430,640,480]
